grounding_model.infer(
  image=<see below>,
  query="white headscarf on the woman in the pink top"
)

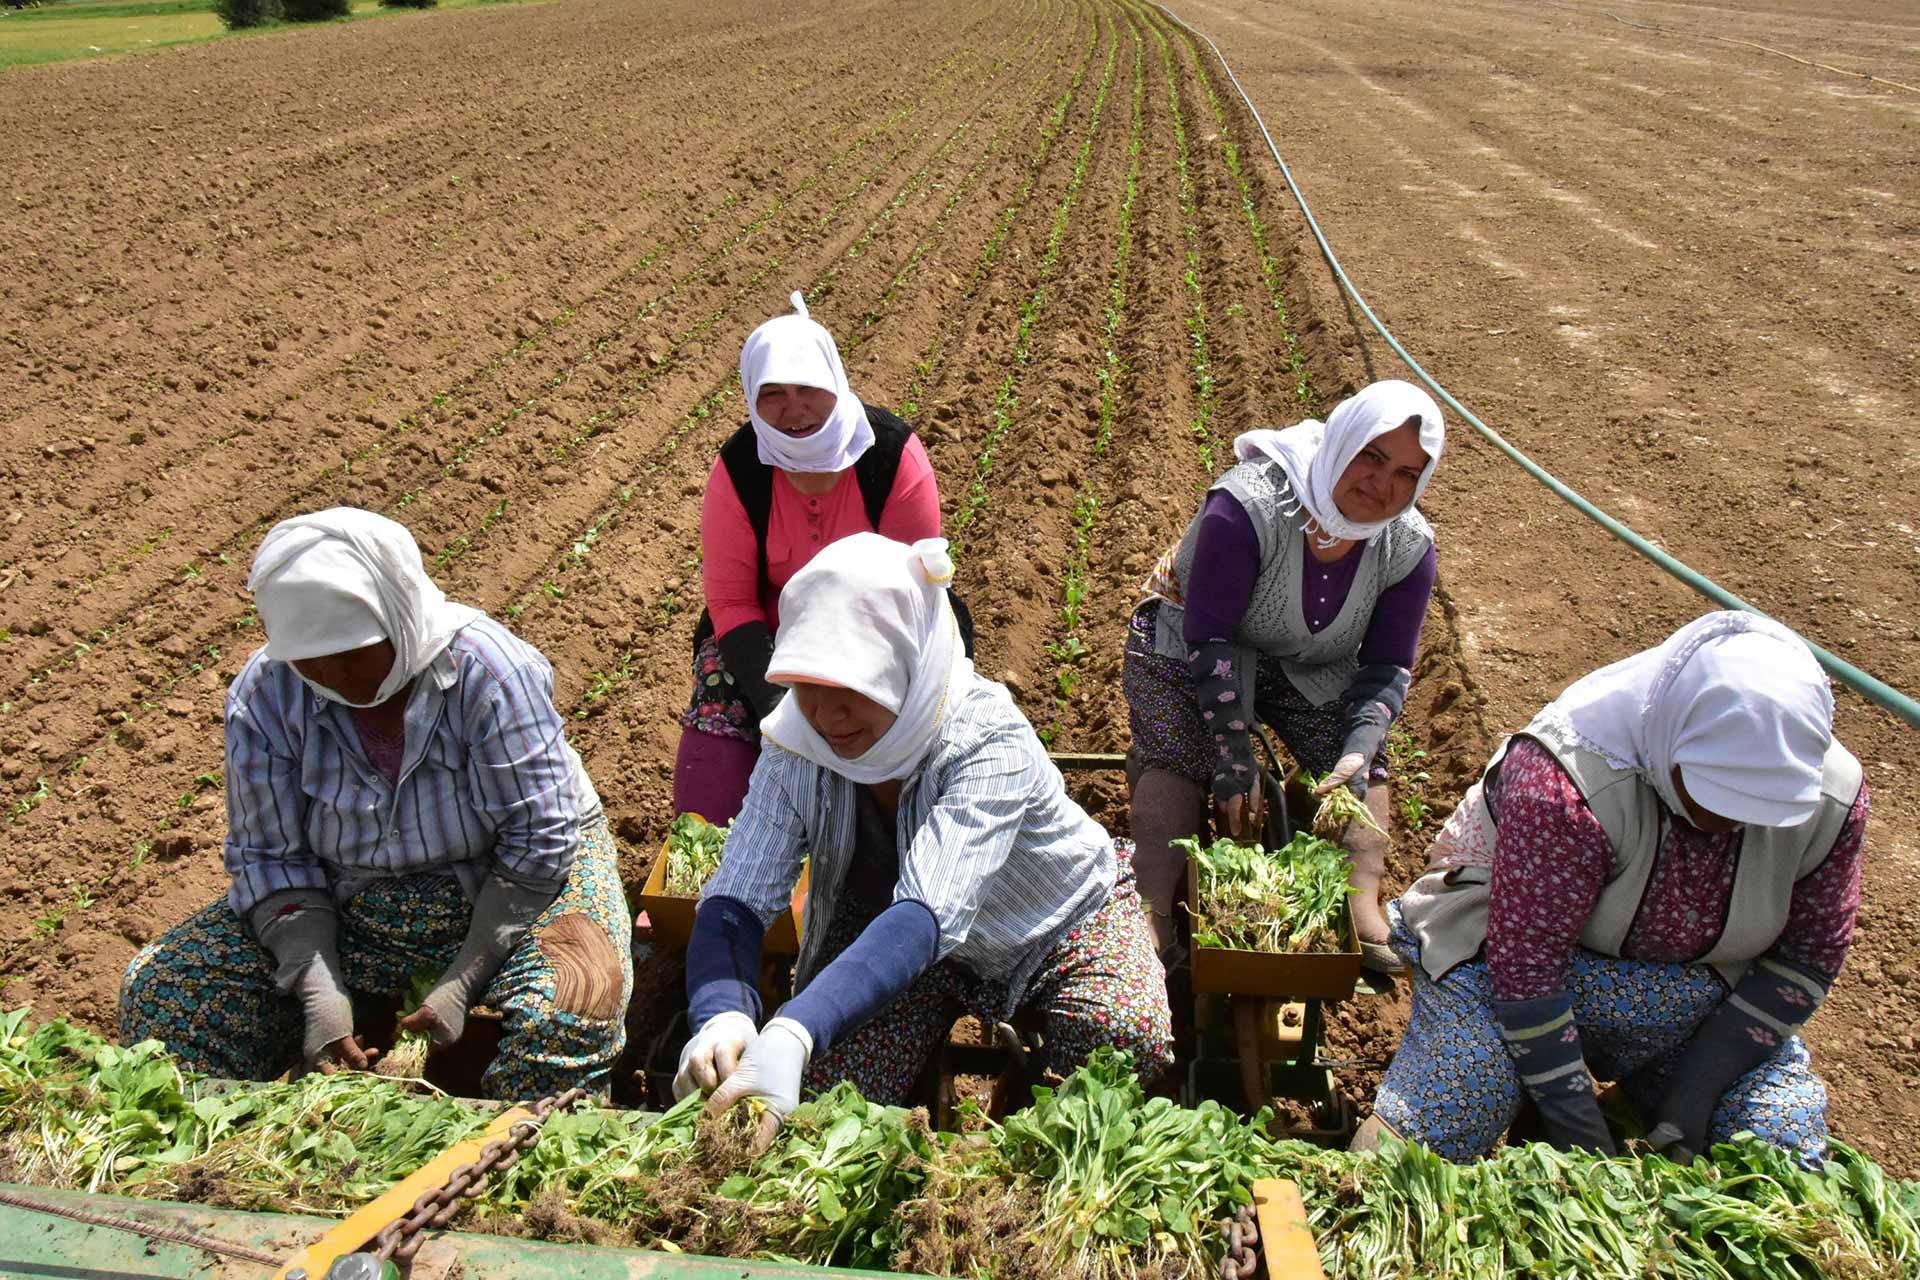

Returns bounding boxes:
[739,294,874,472]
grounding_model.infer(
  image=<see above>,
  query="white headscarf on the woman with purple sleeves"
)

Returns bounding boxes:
[1233,378,1446,547]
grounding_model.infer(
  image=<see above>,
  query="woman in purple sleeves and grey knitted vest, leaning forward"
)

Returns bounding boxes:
[1121,380,1444,971]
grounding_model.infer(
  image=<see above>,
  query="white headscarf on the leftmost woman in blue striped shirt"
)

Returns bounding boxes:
[246,507,482,706]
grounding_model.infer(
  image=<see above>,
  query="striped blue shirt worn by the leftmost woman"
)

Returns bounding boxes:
[227,618,601,915]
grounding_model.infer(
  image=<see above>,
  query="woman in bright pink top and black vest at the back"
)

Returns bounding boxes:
[674,294,941,823]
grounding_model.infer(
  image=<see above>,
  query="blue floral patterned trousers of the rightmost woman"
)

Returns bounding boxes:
[1373,902,1826,1161]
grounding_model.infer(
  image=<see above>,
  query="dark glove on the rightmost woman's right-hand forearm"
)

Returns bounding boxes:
[1647,956,1832,1165]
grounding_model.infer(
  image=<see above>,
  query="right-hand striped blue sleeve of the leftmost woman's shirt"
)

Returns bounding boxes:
[461,662,580,885]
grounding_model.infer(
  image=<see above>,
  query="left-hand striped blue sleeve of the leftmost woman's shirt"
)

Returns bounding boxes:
[223,652,326,919]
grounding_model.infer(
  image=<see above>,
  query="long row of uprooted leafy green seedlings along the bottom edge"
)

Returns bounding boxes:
[0,1009,1920,1280]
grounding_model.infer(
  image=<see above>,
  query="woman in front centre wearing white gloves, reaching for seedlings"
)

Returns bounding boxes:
[674,533,1171,1115]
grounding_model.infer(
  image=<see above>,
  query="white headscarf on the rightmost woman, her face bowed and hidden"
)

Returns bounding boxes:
[1544,612,1834,827]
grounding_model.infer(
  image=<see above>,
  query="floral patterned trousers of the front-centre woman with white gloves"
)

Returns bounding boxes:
[804,841,1173,1105]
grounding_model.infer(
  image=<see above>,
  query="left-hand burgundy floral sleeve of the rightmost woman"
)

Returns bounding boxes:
[1486,737,1613,1000]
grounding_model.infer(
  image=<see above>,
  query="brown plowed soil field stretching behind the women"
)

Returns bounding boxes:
[0,0,1920,1174]
